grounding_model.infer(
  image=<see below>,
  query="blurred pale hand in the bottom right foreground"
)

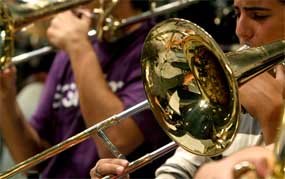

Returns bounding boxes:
[195,147,274,179]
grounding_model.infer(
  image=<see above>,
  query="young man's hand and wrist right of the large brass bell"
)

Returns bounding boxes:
[239,65,285,143]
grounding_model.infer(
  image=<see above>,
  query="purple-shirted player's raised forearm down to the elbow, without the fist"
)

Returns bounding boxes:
[69,42,143,157]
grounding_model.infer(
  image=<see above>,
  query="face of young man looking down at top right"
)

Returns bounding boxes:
[234,0,285,47]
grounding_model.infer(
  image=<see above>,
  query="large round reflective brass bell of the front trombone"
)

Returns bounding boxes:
[142,19,239,156]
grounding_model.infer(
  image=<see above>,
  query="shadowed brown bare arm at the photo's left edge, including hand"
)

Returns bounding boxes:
[0,67,49,162]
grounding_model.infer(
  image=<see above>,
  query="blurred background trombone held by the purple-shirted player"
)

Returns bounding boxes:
[12,0,200,64]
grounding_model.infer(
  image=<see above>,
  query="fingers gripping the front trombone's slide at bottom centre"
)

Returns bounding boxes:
[90,158,129,179]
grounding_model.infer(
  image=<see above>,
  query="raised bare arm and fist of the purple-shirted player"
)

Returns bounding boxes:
[48,11,144,157]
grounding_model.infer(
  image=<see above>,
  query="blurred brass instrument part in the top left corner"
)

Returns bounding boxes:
[0,0,92,70]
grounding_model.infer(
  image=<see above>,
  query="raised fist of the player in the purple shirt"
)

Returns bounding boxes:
[47,9,91,52]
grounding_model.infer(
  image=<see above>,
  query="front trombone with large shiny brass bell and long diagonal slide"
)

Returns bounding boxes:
[0,18,285,178]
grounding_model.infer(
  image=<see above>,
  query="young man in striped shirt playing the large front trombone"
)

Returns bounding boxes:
[90,0,285,179]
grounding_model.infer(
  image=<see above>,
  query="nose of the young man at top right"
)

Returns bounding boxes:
[236,15,254,44]
